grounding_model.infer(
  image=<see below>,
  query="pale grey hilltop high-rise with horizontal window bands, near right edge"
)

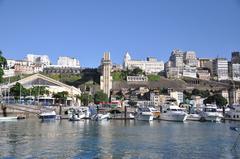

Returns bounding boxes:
[213,58,229,81]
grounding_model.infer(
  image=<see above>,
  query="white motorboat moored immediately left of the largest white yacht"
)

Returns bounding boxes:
[135,107,154,121]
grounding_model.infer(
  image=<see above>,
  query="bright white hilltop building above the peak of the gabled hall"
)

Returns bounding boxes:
[25,54,51,66]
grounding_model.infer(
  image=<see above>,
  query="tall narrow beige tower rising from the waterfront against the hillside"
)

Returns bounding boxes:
[100,52,112,97]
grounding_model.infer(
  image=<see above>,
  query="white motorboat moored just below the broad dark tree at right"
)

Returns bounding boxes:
[200,104,223,122]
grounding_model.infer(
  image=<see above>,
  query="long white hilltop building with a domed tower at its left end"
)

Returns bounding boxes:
[123,52,164,74]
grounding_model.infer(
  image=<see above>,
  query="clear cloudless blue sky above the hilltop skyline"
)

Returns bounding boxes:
[0,0,240,67]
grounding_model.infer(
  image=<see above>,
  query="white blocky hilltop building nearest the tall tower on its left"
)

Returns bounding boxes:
[57,56,80,67]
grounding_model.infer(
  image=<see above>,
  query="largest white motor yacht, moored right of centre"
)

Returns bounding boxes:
[160,103,187,122]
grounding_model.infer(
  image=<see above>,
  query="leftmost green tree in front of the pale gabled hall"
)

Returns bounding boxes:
[10,82,28,99]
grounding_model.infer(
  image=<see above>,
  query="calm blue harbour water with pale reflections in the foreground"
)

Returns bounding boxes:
[0,119,240,159]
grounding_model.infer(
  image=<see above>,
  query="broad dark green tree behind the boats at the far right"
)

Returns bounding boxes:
[203,94,227,107]
